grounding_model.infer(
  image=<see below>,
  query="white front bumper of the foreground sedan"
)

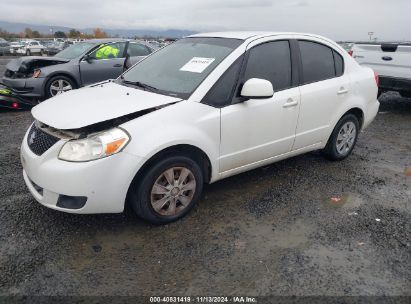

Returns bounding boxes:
[21,123,145,214]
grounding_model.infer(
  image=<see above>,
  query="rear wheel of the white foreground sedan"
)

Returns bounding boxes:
[322,114,360,161]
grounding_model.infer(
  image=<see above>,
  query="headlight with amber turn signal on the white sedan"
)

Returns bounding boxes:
[59,128,130,162]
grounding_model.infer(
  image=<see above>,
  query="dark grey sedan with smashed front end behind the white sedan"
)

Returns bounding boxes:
[2,39,152,103]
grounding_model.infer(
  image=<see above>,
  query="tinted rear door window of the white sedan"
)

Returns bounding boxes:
[299,41,335,84]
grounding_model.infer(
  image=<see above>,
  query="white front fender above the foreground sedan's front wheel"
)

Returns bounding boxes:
[121,101,220,181]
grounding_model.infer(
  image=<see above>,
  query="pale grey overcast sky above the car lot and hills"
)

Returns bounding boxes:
[0,0,411,40]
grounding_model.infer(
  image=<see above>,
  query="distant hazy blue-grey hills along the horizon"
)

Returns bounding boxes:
[0,21,196,38]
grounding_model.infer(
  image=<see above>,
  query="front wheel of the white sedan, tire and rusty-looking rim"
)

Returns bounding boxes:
[129,156,204,224]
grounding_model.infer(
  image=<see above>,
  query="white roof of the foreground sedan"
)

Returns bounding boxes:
[188,31,328,40]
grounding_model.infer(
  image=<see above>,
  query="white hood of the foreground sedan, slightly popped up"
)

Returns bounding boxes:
[31,82,181,130]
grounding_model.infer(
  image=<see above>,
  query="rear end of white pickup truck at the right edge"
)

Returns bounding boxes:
[350,43,411,97]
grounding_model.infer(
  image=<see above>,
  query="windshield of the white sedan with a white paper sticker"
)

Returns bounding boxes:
[119,38,243,99]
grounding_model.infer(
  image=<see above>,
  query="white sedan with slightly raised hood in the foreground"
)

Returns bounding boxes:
[21,32,379,224]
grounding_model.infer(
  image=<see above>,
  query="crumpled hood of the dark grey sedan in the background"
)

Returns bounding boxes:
[6,56,70,73]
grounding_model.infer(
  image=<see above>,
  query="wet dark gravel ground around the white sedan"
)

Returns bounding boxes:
[0,62,411,296]
